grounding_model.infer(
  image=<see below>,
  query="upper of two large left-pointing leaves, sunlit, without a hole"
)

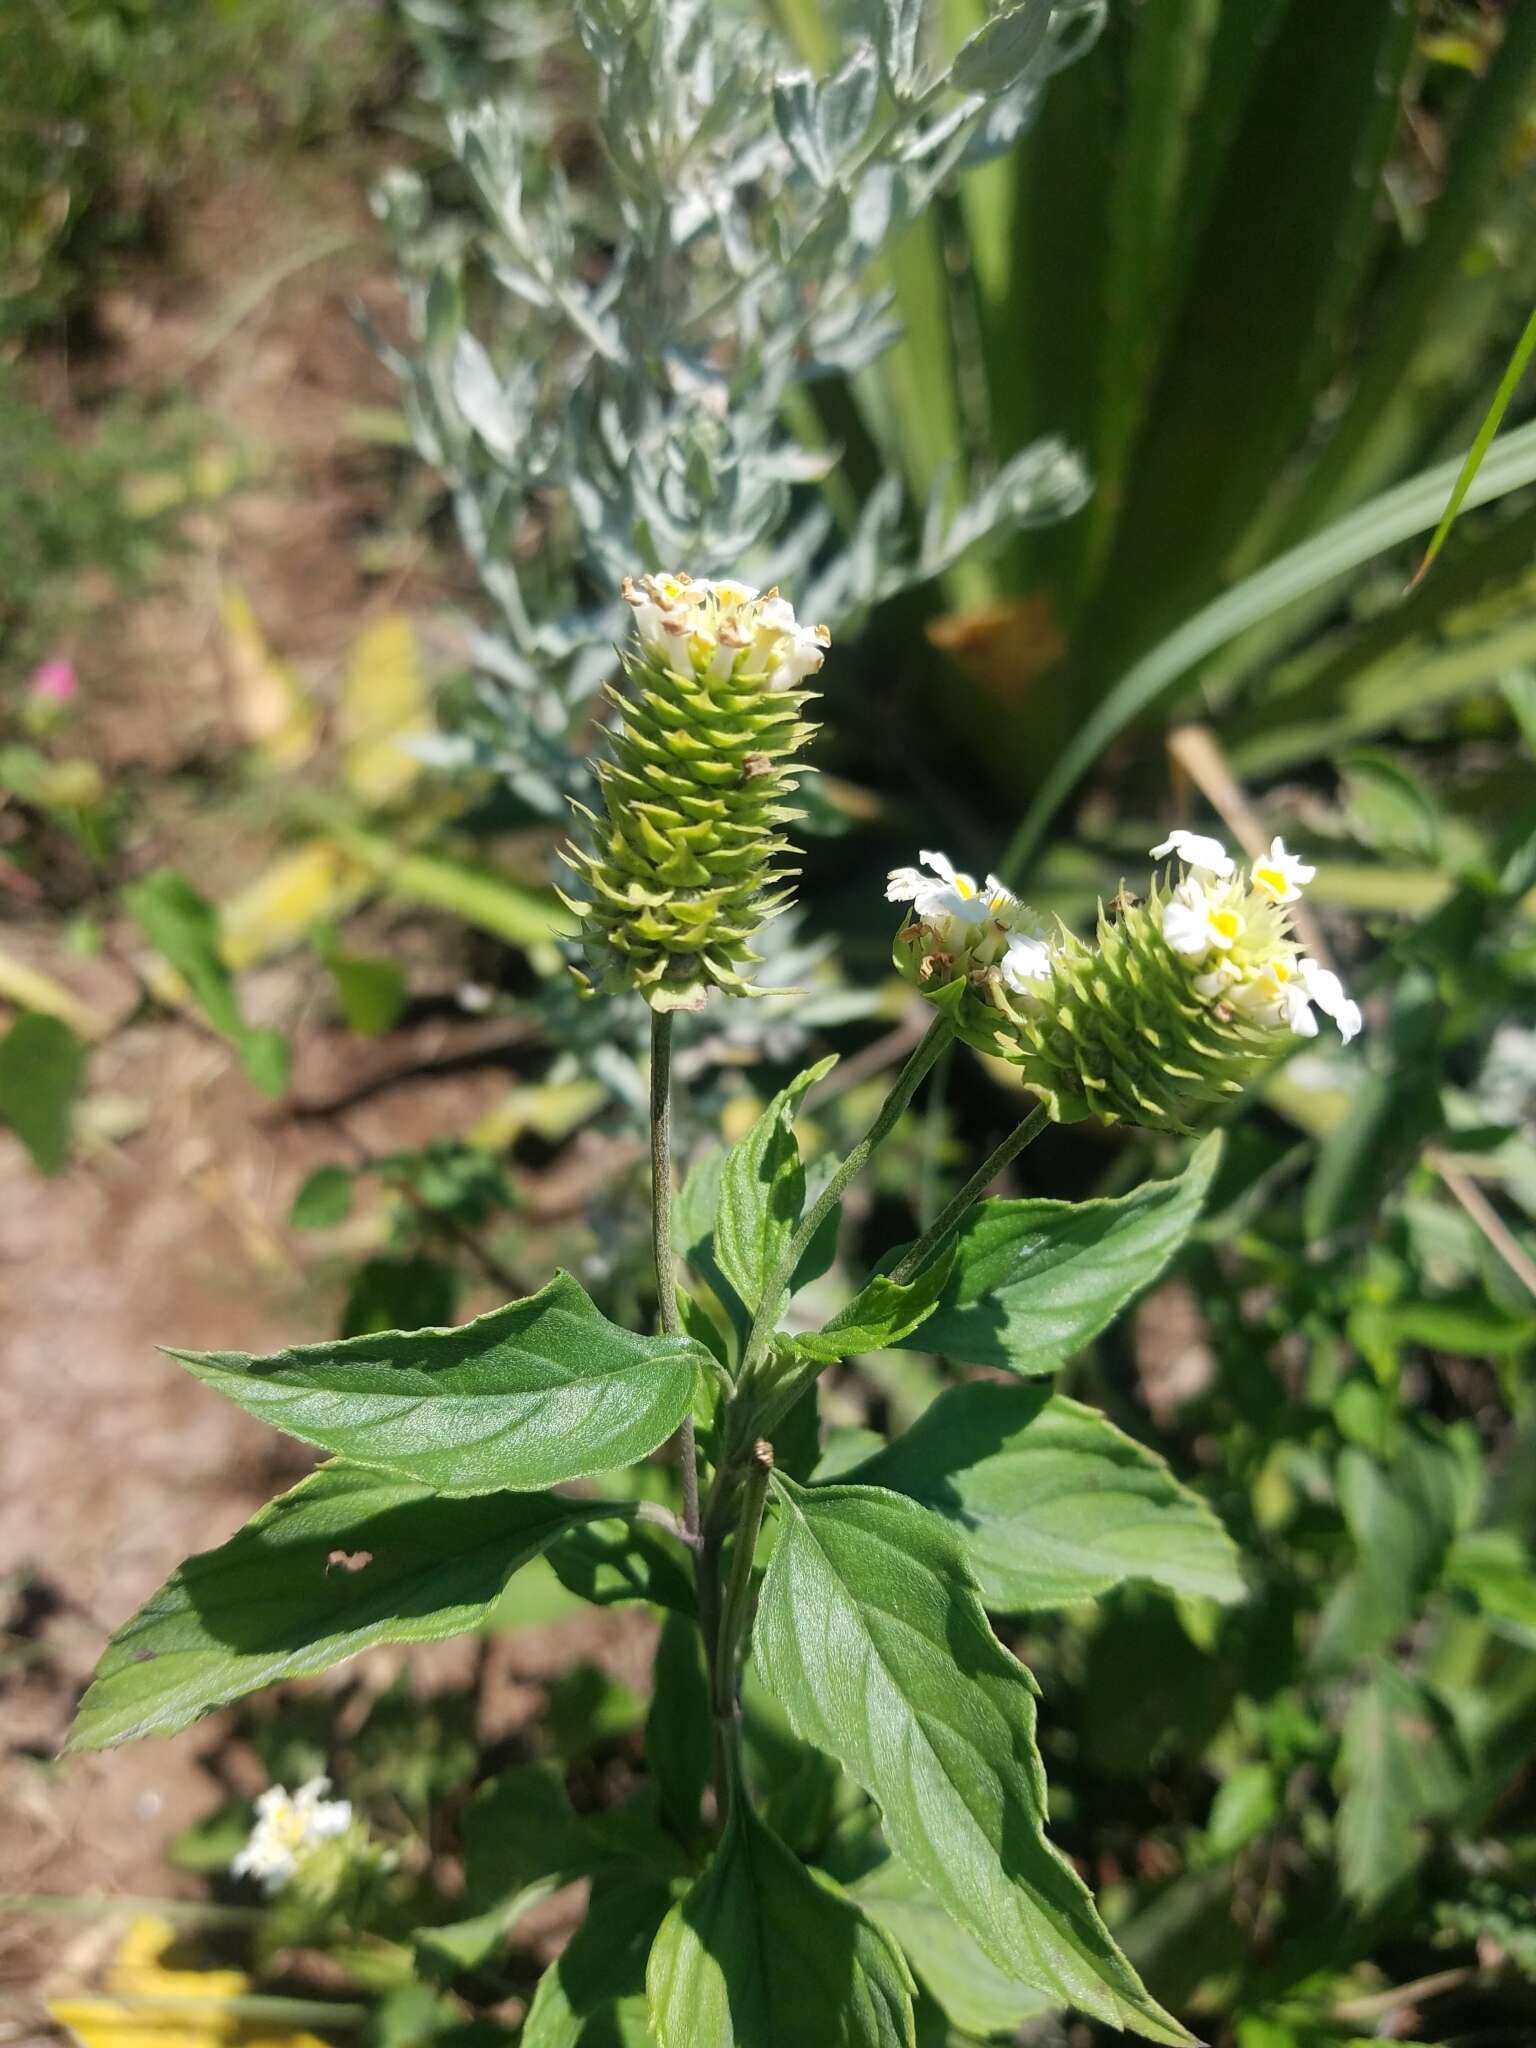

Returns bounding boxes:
[170,1274,709,1493]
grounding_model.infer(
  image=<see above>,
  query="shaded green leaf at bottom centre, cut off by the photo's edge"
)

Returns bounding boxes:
[647,1796,915,2048]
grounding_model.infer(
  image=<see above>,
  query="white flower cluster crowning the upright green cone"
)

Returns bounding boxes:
[625,575,831,690]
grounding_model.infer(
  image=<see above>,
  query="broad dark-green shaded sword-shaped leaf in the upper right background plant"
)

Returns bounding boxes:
[1081,0,1413,663]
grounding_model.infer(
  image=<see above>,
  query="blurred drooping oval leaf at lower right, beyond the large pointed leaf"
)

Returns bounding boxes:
[1337,1663,1466,1907]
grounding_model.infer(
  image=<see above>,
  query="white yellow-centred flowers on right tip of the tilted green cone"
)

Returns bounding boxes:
[1151,831,1360,1044]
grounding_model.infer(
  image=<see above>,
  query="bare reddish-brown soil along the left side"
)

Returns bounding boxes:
[0,159,647,2040]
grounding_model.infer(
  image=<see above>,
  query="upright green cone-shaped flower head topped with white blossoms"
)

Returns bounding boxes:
[563,575,829,1010]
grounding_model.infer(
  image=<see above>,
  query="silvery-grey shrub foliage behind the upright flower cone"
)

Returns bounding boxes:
[379,0,1102,819]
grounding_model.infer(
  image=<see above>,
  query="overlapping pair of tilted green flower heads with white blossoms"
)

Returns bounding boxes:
[887,831,1360,1130]
